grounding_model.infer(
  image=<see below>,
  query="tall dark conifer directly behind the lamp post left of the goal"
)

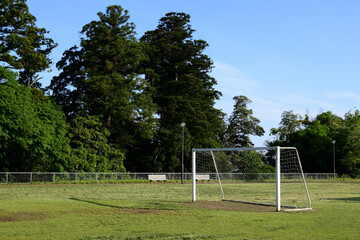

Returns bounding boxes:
[141,12,223,171]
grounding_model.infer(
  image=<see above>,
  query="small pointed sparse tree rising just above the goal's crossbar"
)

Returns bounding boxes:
[224,96,265,147]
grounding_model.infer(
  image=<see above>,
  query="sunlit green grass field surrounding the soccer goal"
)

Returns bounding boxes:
[0,182,360,239]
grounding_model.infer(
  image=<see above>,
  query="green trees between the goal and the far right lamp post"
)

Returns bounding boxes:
[268,111,341,172]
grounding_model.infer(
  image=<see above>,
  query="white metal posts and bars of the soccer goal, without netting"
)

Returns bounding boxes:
[192,146,312,211]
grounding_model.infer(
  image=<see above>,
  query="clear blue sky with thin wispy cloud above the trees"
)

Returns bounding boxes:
[27,0,360,146]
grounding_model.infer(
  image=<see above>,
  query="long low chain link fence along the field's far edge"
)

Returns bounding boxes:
[0,172,338,184]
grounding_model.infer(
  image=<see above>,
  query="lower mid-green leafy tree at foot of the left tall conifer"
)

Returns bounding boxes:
[69,116,125,172]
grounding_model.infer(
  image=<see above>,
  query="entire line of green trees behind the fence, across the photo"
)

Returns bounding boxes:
[0,0,359,176]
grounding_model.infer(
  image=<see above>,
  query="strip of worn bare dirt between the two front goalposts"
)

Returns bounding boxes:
[191,201,276,212]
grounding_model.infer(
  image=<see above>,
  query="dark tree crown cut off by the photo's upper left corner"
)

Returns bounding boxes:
[0,0,57,87]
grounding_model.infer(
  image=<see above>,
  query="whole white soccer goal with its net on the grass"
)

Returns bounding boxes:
[192,147,311,211]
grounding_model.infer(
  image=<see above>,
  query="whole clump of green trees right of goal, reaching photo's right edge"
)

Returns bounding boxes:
[268,110,360,177]
